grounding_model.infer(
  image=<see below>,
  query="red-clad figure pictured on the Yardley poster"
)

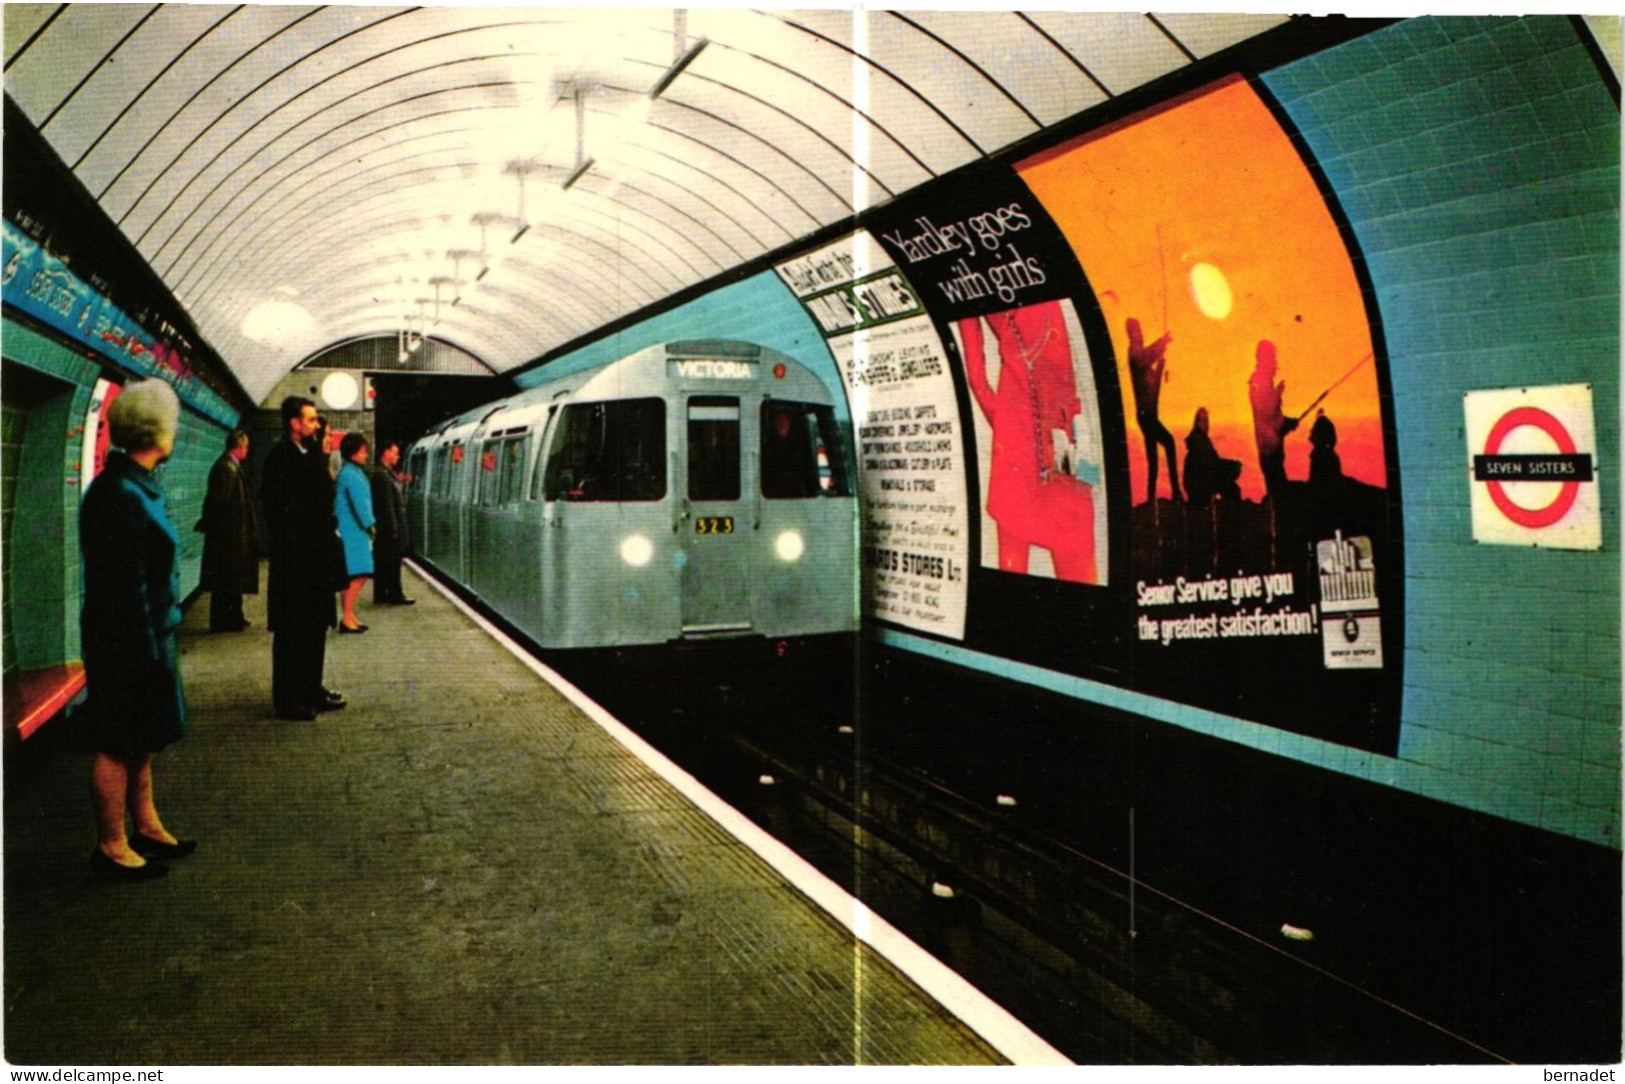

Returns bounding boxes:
[959,301,1097,583]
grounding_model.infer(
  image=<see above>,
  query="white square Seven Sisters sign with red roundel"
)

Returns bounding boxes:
[1464,384,1602,549]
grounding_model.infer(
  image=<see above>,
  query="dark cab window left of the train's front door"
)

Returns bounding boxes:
[543,398,666,501]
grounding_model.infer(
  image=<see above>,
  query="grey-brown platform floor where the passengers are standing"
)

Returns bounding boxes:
[5,575,1001,1066]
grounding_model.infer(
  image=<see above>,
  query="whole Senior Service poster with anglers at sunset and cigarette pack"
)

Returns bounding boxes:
[1017,76,1401,751]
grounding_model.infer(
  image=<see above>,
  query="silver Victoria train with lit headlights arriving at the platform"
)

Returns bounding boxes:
[405,341,858,648]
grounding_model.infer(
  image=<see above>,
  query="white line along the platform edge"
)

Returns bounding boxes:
[403,561,1074,1066]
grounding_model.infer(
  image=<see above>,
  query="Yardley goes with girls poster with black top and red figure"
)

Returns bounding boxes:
[873,169,1110,594]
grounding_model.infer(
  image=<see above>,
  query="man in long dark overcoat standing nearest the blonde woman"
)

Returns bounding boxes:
[260,395,345,722]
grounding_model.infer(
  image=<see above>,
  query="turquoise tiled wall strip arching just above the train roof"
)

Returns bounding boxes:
[518,271,847,414]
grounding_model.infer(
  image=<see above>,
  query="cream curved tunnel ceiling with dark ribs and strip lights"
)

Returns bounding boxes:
[5,3,1285,400]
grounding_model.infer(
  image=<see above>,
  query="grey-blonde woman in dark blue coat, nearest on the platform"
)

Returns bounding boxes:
[80,380,197,881]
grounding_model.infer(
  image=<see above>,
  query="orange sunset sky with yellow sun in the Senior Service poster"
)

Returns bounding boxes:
[1017,78,1386,505]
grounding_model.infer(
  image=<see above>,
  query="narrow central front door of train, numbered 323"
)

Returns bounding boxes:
[678,395,752,635]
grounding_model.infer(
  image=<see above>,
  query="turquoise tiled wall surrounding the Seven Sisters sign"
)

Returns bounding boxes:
[1264,16,1620,847]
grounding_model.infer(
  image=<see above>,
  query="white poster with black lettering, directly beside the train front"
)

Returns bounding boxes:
[777,231,970,640]
